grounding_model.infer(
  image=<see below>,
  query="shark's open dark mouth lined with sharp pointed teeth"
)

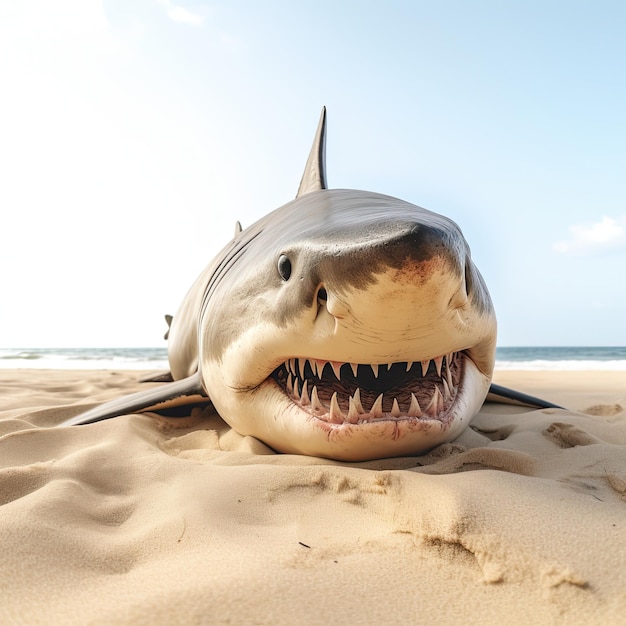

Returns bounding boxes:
[271,352,466,425]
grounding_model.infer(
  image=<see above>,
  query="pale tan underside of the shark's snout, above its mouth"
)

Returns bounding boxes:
[298,246,473,362]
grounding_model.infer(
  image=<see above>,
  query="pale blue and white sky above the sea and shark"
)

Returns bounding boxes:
[0,0,626,347]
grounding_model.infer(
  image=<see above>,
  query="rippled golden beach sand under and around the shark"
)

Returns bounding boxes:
[0,370,626,626]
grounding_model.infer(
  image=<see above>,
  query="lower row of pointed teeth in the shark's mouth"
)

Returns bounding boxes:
[287,375,452,424]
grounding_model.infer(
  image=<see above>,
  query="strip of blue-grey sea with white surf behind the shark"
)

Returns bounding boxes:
[0,346,626,371]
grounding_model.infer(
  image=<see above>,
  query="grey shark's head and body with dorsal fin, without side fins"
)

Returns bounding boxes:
[170,112,496,461]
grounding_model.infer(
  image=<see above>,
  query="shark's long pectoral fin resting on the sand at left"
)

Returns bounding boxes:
[61,372,204,426]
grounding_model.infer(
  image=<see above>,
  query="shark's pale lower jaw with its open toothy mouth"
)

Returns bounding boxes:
[202,334,490,462]
